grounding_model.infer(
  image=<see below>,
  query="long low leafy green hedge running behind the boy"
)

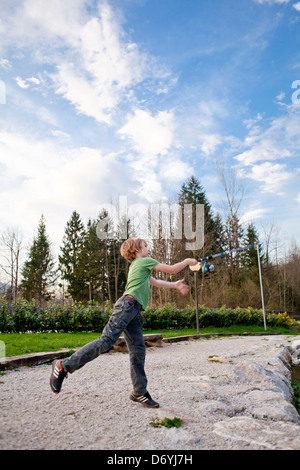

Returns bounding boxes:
[0,300,296,333]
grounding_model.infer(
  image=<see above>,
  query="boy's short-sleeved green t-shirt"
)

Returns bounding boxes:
[123,258,159,310]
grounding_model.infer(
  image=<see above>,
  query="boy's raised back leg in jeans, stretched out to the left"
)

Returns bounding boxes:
[63,297,139,373]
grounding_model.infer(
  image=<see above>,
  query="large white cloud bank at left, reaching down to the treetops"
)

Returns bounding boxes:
[0,132,133,247]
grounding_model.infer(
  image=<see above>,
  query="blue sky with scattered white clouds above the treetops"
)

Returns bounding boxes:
[0,0,300,268]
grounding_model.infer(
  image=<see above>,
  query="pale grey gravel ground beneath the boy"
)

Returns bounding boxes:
[0,336,300,451]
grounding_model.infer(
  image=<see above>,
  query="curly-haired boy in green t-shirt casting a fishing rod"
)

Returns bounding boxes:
[50,238,197,408]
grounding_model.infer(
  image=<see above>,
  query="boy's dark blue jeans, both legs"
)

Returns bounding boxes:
[63,296,147,395]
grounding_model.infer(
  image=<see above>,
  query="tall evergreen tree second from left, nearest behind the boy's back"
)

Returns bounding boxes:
[58,211,88,301]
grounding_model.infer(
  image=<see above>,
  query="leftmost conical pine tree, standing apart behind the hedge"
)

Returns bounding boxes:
[20,215,57,304]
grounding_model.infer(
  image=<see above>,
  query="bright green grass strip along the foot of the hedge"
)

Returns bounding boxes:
[0,326,299,357]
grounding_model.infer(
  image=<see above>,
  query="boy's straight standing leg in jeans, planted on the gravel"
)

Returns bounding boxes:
[123,315,147,395]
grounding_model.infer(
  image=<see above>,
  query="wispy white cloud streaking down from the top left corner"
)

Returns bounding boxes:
[1,0,171,124]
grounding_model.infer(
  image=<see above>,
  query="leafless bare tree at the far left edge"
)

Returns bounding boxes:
[0,228,23,302]
